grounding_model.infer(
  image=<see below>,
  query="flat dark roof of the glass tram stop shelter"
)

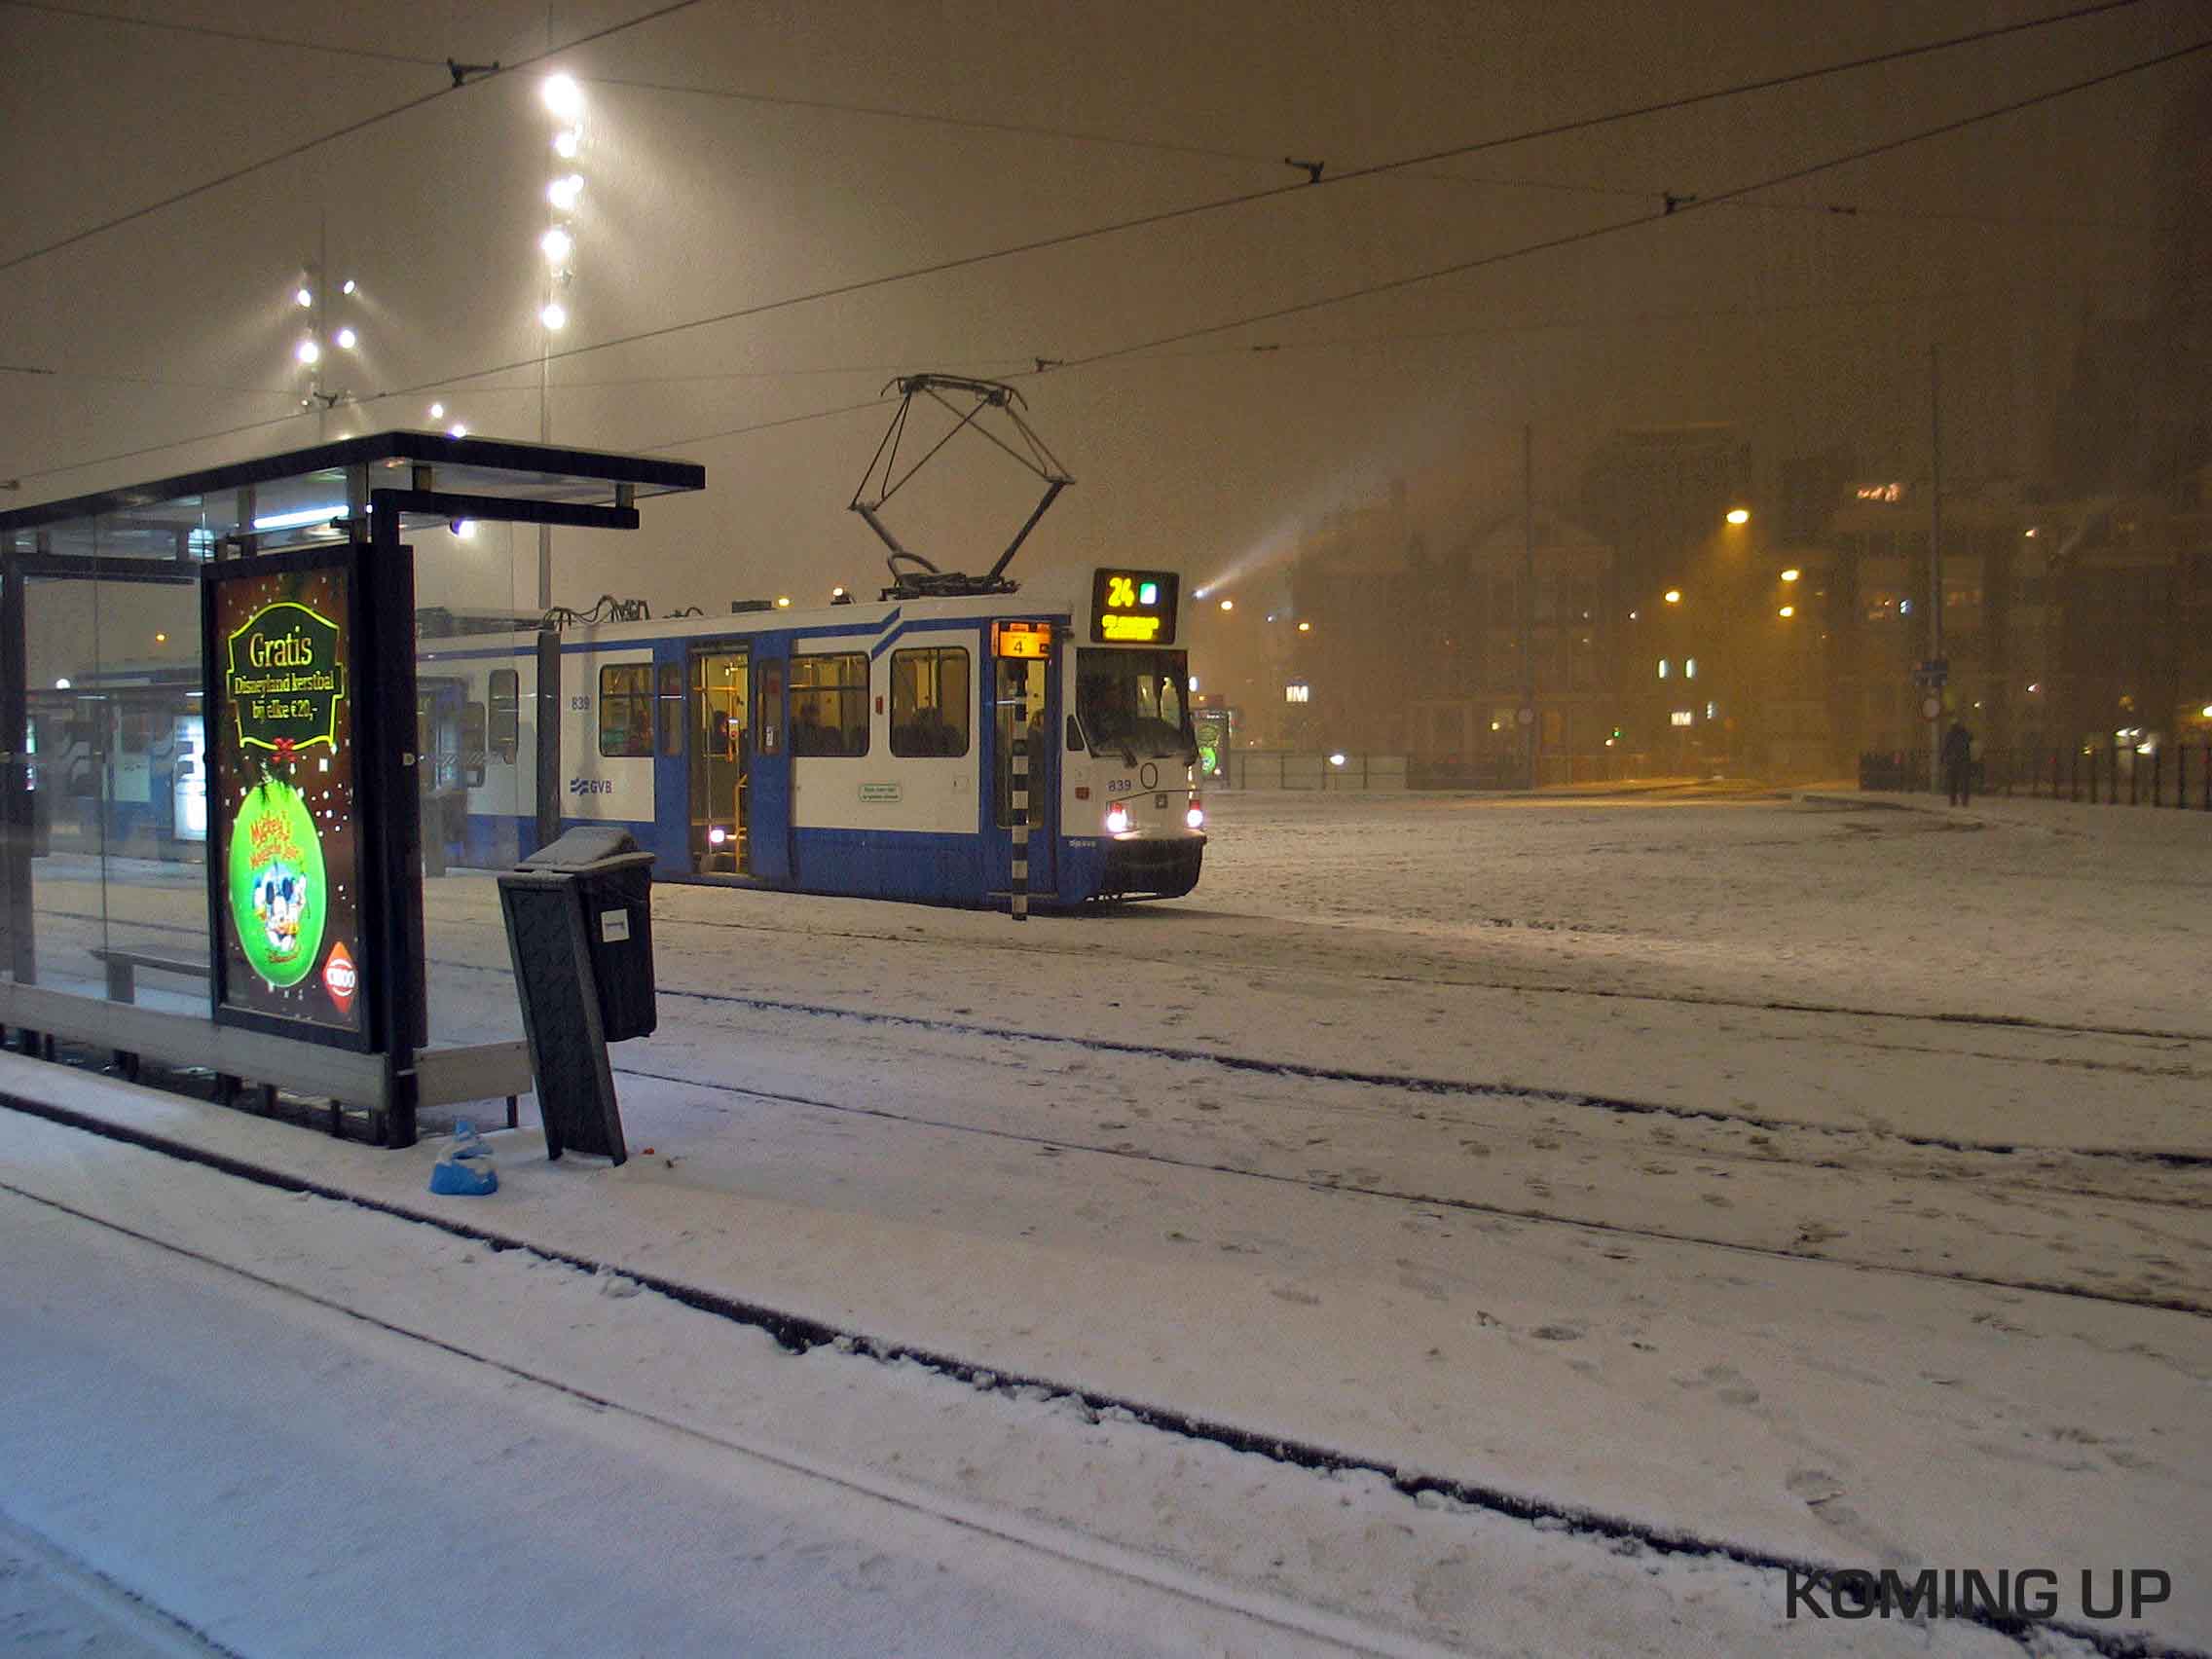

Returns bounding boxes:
[0,431,706,564]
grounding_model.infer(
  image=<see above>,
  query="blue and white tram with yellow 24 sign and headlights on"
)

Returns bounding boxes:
[418,571,1205,904]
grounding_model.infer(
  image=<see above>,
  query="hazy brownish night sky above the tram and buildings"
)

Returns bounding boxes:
[0,0,2212,610]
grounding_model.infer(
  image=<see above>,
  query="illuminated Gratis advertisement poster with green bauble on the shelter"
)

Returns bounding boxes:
[208,564,365,1040]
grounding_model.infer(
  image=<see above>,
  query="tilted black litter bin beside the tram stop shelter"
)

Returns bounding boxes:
[499,828,657,1163]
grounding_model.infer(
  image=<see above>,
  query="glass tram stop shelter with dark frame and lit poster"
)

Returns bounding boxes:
[0,431,706,1146]
